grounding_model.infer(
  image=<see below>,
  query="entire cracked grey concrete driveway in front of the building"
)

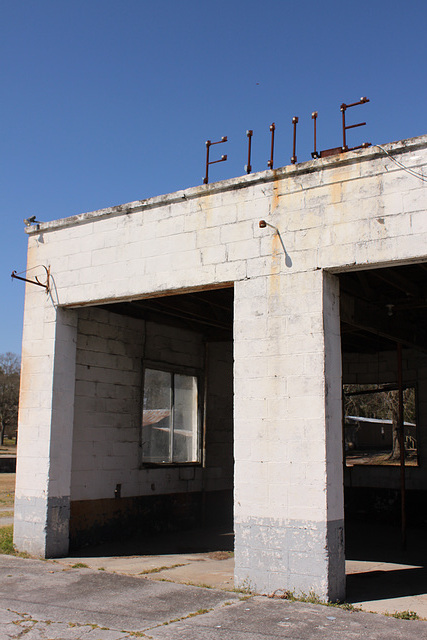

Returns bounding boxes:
[0,556,427,640]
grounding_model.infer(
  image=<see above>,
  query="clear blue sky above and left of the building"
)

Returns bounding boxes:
[0,0,427,353]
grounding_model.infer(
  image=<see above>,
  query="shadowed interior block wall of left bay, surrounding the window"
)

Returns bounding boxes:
[71,307,233,537]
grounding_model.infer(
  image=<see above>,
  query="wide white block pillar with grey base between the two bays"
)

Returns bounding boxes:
[234,270,345,600]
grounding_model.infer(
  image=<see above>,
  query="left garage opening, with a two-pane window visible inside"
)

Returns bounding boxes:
[70,287,233,555]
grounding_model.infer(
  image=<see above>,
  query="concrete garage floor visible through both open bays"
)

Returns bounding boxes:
[52,532,427,619]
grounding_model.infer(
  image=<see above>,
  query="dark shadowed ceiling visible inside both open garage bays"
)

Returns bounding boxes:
[97,263,427,353]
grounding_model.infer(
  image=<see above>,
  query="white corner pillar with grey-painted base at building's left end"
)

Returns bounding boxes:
[14,296,77,557]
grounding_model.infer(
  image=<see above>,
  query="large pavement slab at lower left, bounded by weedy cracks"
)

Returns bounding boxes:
[0,556,239,631]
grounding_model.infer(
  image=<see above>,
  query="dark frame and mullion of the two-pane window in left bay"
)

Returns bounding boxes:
[139,360,204,469]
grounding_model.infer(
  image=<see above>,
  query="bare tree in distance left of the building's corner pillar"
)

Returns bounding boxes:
[0,352,21,444]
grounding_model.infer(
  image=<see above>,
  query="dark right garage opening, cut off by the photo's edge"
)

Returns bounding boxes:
[339,263,427,602]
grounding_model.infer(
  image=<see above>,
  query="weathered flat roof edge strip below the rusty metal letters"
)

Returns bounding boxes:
[25,135,427,235]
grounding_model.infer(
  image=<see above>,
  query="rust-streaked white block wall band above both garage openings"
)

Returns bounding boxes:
[23,137,427,306]
